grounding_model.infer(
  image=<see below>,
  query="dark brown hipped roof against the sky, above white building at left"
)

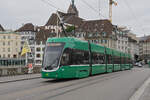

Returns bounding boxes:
[16,23,35,32]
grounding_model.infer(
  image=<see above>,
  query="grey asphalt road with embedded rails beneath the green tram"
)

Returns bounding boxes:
[0,68,150,100]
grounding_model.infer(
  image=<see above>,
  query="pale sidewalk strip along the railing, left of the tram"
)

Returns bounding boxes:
[0,74,41,84]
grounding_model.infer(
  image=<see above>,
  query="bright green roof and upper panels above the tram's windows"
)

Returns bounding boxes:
[47,37,130,57]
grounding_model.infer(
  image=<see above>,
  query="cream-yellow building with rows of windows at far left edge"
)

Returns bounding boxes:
[0,31,21,58]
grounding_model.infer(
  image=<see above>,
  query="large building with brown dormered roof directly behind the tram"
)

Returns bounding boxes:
[76,20,116,49]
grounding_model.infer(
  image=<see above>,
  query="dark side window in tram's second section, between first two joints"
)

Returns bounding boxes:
[92,52,105,64]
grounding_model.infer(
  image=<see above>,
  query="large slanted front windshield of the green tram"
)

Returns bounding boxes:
[43,43,64,70]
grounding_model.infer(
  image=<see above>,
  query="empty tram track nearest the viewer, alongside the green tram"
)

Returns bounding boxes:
[15,70,135,100]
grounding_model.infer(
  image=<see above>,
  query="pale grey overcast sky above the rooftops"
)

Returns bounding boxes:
[0,0,150,36]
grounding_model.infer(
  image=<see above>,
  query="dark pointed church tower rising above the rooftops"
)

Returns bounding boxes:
[67,0,79,16]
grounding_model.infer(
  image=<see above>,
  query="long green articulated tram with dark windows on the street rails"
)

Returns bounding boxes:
[41,37,132,79]
